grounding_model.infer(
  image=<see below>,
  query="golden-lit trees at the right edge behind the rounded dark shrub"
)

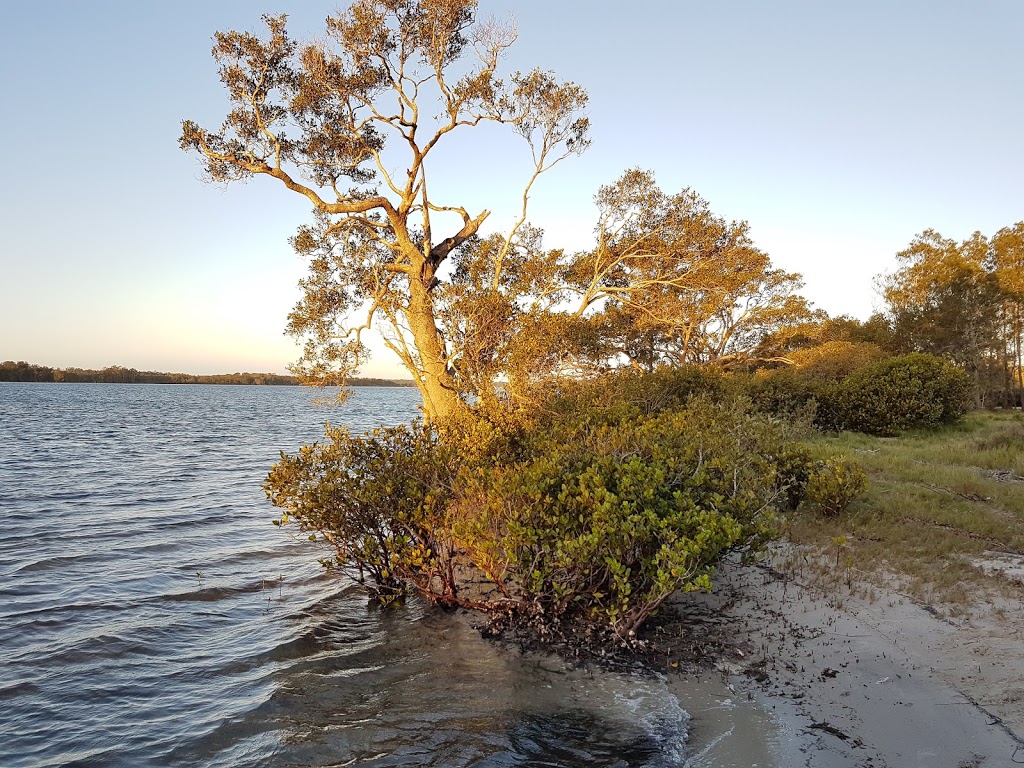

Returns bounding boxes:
[740,221,1024,408]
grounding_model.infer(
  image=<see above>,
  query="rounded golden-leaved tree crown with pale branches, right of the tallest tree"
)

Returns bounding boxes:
[566,169,811,370]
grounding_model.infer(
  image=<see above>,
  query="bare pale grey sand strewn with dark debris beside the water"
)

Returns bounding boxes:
[652,552,1024,768]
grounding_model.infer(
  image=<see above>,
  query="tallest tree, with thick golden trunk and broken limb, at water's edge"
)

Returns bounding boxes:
[180,0,589,419]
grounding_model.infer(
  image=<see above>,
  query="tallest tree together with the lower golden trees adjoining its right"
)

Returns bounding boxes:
[180,6,811,420]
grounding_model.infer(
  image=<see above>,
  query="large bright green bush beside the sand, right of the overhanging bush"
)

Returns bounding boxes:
[453,400,793,637]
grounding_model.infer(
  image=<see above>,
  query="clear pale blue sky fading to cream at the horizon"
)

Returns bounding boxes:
[0,0,1024,377]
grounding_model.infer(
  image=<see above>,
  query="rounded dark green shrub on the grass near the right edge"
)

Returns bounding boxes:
[836,353,971,436]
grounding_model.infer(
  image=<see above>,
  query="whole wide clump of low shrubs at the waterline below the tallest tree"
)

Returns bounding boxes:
[265,369,835,638]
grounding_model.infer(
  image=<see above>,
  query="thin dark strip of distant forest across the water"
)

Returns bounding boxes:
[0,360,415,387]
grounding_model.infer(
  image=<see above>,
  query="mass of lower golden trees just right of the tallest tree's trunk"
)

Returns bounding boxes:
[419,169,810,399]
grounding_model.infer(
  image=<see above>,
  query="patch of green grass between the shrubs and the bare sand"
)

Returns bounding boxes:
[788,412,1024,605]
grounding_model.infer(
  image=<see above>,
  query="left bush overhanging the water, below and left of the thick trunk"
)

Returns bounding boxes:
[263,425,457,603]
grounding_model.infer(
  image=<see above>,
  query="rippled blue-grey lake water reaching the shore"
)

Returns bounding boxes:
[0,384,765,768]
